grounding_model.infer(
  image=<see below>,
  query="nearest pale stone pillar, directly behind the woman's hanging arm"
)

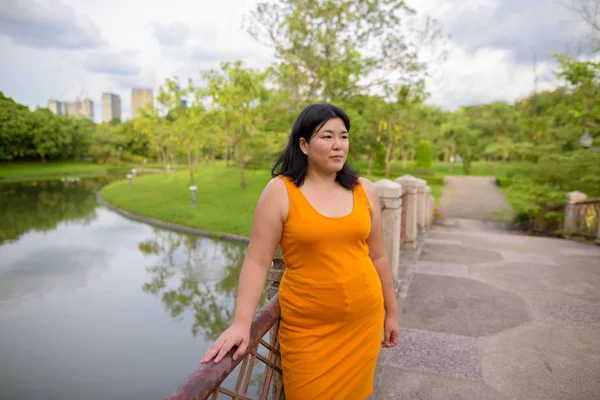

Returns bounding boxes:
[374,179,402,288]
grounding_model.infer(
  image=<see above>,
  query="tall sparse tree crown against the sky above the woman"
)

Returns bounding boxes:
[248,0,441,103]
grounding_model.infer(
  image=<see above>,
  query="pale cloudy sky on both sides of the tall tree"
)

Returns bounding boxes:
[0,0,590,122]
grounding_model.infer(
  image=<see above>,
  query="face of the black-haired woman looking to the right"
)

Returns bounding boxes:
[300,118,350,172]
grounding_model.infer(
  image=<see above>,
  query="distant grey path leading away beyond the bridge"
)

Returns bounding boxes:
[440,176,512,221]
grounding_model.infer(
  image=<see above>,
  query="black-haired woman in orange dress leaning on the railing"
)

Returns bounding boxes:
[202,104,400,400]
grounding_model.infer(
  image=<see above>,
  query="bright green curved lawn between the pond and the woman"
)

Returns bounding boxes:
[101,166,441,236]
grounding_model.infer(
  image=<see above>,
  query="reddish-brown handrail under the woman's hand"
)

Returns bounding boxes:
[167,295,281,400]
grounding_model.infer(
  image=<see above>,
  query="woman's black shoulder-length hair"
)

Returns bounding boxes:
[271,104,358,190]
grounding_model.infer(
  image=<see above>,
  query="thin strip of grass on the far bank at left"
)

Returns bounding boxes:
[0,161,128,177]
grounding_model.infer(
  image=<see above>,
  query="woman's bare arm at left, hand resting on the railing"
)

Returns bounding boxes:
[201,178,289,363]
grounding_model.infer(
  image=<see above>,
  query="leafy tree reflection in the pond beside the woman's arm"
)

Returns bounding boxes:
[138,229,265,341]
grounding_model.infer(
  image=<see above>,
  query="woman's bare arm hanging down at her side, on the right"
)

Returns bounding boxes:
[359,178,400,347]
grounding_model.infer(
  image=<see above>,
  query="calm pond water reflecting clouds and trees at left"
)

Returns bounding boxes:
[0,177,262,400]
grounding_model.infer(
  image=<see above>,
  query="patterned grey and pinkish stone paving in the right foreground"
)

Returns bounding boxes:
[371,220,600,400]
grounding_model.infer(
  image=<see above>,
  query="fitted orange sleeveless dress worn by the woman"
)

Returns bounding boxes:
[279,177,384,400]
